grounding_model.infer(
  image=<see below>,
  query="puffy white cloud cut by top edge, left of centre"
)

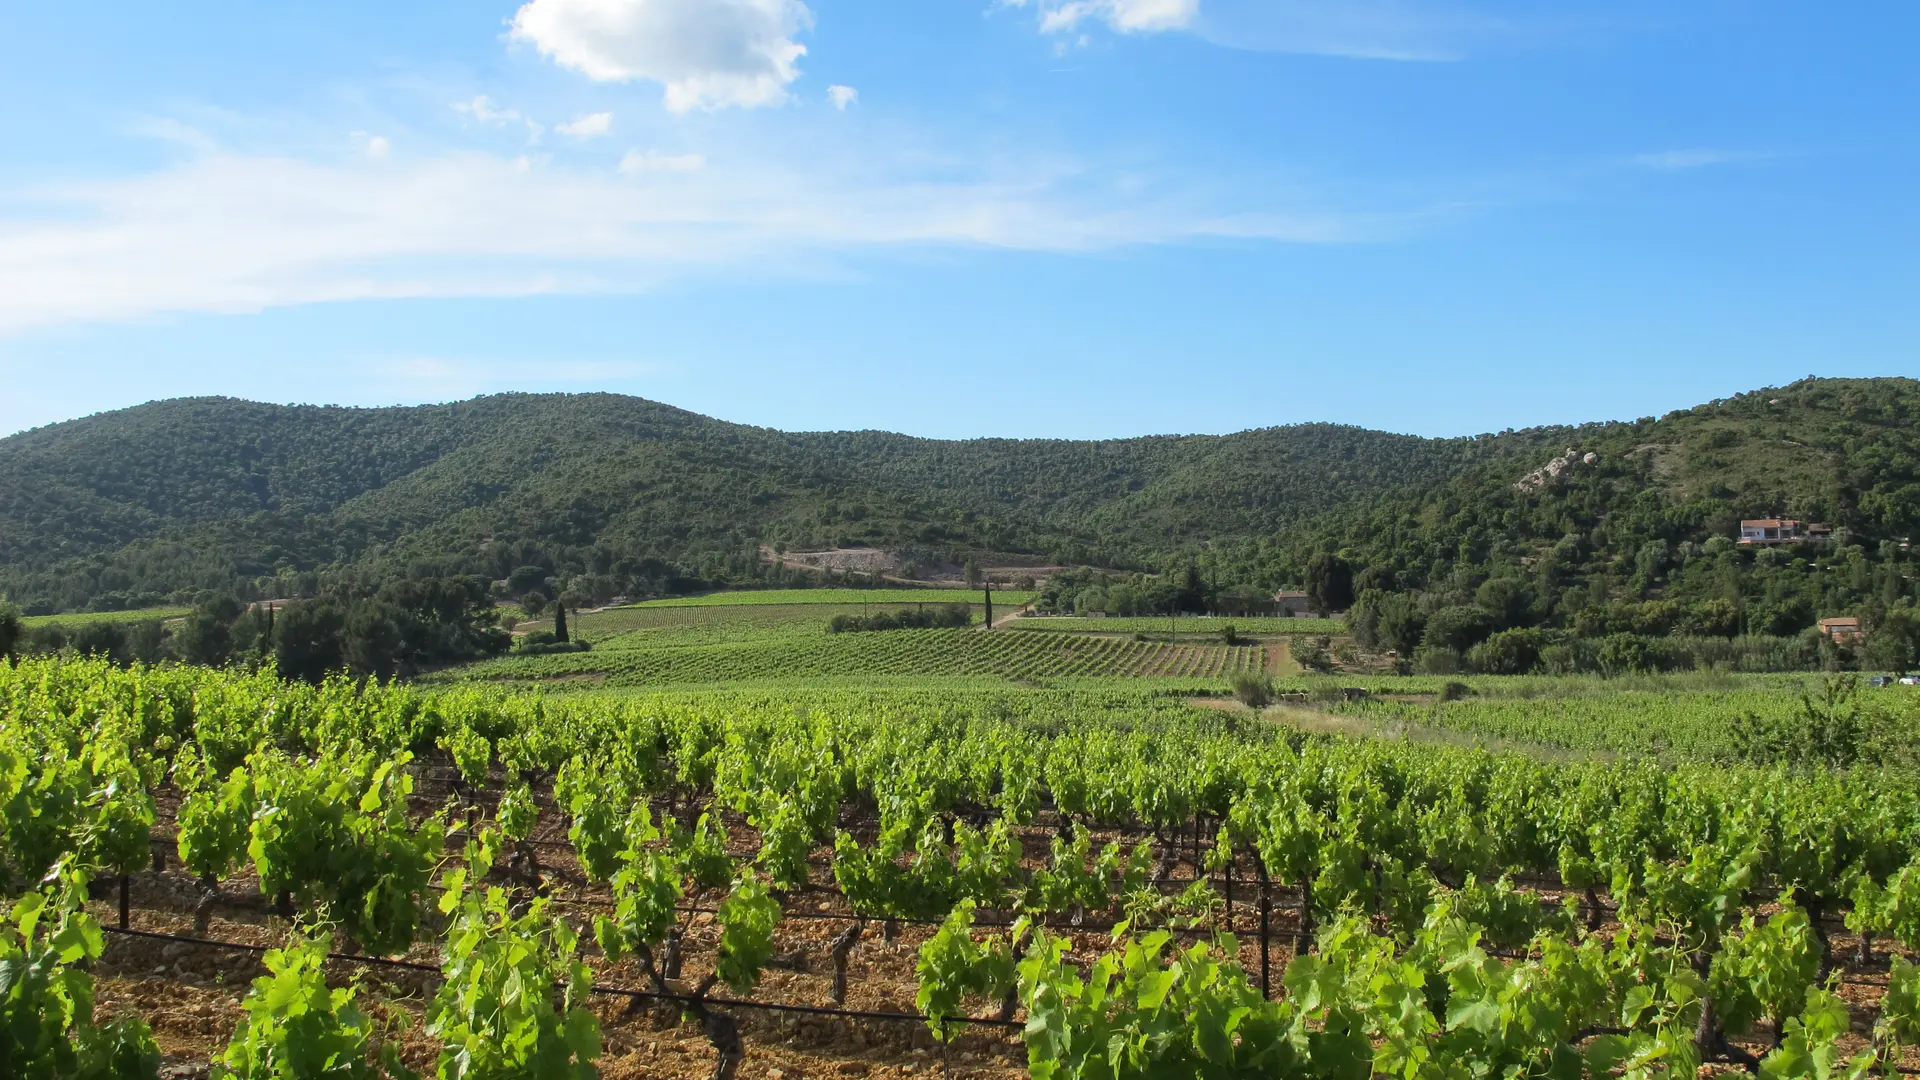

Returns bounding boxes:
[513,0,812,111]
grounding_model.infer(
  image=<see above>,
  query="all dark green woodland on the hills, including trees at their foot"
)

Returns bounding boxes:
[0,379,1920,675]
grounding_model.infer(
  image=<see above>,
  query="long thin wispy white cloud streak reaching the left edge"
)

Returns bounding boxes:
[0,148,1382,334]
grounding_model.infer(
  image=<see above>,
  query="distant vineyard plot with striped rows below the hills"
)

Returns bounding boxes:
[459,630,1265,686]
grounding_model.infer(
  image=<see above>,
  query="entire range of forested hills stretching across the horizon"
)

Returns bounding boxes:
[0,379,1920,622]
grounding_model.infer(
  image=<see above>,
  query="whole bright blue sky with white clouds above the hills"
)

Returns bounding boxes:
[0,0,1920,436]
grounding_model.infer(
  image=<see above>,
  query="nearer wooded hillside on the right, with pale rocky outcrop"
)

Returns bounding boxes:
[1294,379,1920,671]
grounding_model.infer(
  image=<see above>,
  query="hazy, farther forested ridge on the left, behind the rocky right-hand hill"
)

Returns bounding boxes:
[0,386,1497,609]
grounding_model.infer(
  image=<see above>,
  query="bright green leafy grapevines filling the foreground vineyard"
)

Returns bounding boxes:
[18,661,1920,1080]
